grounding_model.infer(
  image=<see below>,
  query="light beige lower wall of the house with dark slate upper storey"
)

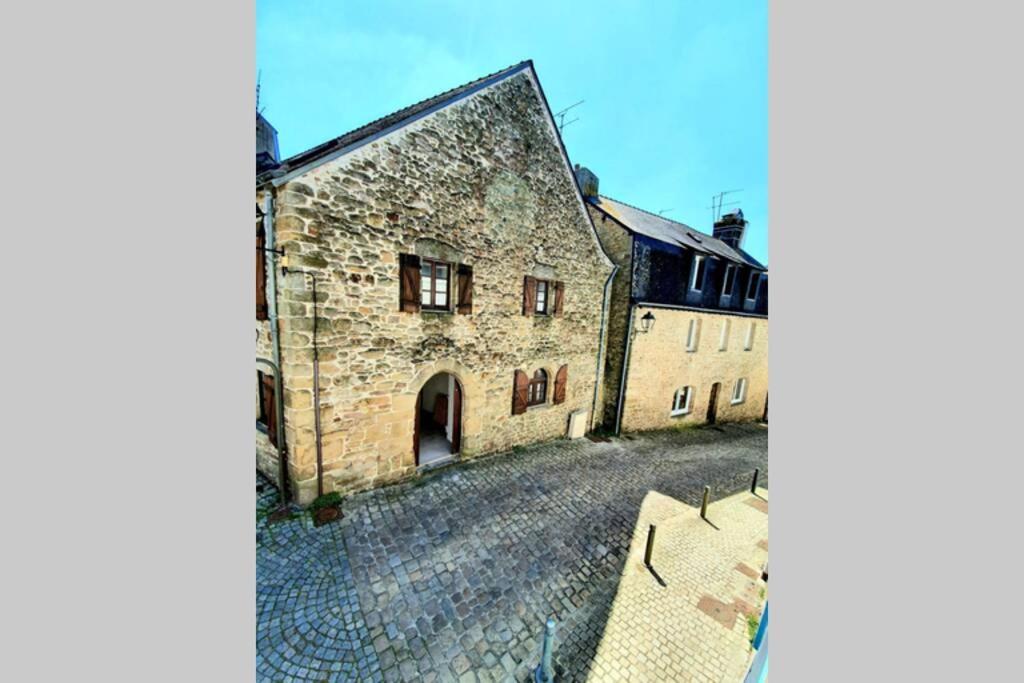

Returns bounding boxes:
[622,306,768,431]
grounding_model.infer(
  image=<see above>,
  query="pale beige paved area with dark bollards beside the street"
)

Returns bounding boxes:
[590,489,768,683]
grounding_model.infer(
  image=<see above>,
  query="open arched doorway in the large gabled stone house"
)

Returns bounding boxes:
[413,373,462,466]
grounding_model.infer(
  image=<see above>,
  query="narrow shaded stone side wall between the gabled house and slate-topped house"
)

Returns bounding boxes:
[587,205,633,429]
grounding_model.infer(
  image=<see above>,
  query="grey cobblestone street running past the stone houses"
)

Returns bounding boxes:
[256,425,768,682]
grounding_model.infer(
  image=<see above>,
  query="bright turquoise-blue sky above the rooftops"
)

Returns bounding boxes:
[256,0,768,263]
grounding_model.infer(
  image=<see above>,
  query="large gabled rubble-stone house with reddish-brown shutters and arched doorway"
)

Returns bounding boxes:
[256,61,614,503]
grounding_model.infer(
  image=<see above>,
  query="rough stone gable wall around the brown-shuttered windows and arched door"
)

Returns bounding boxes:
[258,69,611,503]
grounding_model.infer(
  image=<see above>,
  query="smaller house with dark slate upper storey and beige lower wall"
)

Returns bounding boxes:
[577,166,768,433]
